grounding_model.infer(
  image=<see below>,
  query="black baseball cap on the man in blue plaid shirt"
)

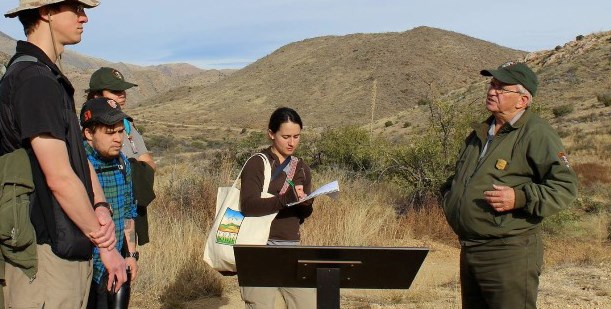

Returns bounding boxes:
[80,98,133,128]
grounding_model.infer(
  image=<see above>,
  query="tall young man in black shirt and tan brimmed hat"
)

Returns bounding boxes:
[0,0,126,308]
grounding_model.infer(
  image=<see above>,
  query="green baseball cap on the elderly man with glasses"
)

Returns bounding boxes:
[479,61,539,96]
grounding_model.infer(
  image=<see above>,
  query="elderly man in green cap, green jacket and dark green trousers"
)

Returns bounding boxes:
[443,62,577,308]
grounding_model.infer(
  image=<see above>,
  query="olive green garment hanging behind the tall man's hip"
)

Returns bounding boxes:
[0,149,37,279]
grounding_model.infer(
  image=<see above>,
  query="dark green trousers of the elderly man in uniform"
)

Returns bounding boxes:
[460,233,543,309]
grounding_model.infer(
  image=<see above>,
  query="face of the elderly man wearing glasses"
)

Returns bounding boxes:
[486,78,523,115]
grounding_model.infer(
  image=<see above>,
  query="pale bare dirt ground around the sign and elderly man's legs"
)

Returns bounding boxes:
[130,245,611,309]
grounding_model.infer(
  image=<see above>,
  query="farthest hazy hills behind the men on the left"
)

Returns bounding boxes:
[0,32,235,106]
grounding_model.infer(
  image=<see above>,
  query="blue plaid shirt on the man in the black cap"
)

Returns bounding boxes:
[84,141,137,284]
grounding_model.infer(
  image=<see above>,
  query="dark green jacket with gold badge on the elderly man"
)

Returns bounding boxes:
[443,110,577,241]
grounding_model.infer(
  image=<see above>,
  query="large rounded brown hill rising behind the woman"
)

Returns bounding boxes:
[131,27,527,128]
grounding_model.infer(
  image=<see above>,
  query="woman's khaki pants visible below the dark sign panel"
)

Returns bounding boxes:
[240,287,316,309]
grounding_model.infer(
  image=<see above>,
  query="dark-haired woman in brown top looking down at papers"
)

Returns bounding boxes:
[240,107,316,308]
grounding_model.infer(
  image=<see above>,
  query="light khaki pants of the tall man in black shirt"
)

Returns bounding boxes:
[4,245,93,309]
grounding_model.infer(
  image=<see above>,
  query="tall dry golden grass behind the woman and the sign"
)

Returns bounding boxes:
[132,155,611,308]
